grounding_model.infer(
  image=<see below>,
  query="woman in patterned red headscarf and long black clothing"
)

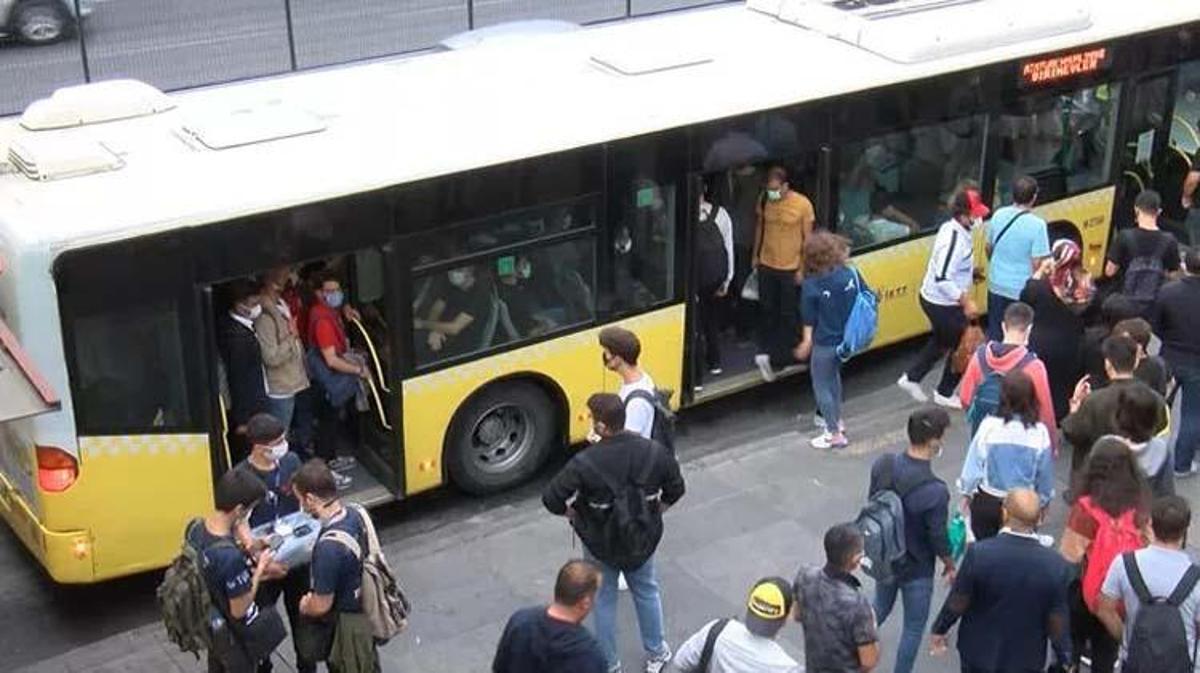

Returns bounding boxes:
[1021,239,1094,421]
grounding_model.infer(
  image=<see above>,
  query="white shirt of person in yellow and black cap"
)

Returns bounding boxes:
[667,619,803,673]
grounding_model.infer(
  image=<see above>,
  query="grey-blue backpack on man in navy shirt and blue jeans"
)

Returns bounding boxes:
[854,453,937,582]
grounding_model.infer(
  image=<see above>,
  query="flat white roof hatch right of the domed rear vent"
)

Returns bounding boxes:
[182,101,325,150]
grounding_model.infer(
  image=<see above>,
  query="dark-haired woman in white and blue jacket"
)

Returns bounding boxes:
[958,369,1054,540]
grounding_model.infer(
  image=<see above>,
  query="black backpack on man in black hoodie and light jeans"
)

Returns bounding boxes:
[578,441,662,571]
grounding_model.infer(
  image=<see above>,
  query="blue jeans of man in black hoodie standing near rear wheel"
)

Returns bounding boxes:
[584,549,667,669]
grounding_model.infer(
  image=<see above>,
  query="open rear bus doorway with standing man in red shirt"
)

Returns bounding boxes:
[206,248,403,505]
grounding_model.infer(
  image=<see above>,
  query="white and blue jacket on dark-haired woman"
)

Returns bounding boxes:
[958,416,1054,507]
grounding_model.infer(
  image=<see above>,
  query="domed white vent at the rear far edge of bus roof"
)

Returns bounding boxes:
[20,79,175,131]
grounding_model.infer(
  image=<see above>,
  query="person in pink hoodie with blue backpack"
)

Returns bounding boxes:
[959,301,1057,445]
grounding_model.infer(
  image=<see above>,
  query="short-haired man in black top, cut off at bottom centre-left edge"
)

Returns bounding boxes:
[492,560,608,673]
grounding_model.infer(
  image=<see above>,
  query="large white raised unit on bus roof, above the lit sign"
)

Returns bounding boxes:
[746,0,1092,64]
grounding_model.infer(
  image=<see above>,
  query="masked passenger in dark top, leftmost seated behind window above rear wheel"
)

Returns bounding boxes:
[413,266,492,363]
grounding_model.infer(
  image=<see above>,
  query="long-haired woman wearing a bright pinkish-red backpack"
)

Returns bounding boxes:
[1058,437,1151,673]
